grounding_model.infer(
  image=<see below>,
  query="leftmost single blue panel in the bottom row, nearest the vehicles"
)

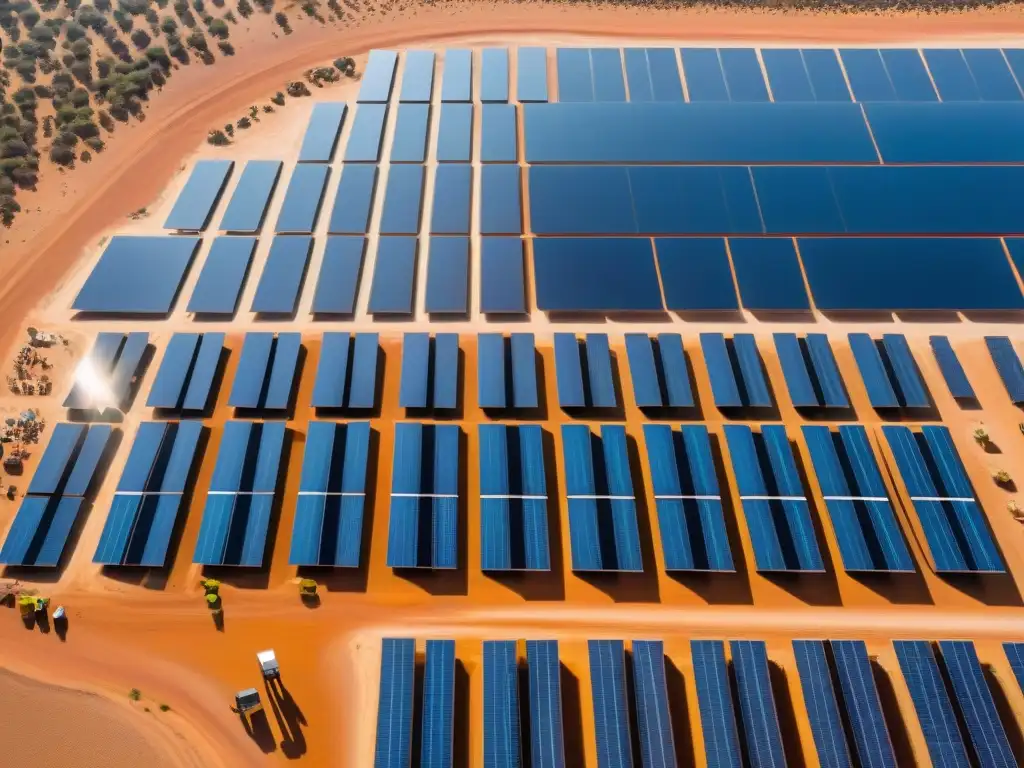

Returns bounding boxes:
[374,637,416,768]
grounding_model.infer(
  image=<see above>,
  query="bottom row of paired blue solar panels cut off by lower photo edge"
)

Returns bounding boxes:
[374,638,1024,768]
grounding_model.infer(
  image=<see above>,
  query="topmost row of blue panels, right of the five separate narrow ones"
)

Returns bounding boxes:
[556,48,1024,101]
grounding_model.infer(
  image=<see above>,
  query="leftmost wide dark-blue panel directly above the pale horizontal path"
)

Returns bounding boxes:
[534,238,663,312]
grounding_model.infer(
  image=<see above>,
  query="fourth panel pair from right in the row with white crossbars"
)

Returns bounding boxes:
[643,424,734,571]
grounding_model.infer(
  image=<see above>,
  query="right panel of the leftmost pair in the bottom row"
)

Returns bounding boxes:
[420,640,456,768]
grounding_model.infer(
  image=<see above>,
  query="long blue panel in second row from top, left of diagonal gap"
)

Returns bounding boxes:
[522,101,879,164]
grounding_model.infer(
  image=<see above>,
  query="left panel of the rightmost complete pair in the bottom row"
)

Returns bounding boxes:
[893,640,966,768]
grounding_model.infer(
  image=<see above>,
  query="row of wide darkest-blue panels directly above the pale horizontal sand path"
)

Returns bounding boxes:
[531,237,1024,313]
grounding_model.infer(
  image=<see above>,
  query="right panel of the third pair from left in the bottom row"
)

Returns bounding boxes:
[633,640,676,768]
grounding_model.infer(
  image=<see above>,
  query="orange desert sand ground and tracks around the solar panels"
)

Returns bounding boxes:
[0,3,1024,768]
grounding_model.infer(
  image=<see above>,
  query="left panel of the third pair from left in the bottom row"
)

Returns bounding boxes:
[587,640,633,768]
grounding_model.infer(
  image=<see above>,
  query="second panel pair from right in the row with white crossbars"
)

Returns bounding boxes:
[802,425,914,571]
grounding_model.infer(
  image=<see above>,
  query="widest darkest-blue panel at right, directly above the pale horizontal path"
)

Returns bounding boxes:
[798,238,1024,311]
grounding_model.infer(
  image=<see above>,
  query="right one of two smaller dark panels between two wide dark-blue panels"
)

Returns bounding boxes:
[729,238,811,311]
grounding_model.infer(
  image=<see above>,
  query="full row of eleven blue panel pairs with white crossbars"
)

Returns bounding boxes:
[2,411,1005,572]
